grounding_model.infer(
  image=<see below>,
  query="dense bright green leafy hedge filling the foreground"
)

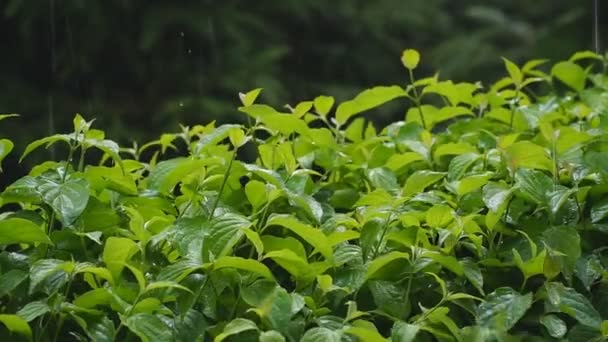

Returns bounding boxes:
[0,50,608,342]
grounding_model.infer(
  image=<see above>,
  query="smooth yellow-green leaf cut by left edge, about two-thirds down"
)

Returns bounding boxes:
[0,217,53,245]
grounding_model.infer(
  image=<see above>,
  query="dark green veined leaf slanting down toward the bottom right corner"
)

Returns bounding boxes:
[545,282,602,331]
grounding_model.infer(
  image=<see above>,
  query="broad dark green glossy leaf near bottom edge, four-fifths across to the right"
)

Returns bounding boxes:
[477,287,532,331]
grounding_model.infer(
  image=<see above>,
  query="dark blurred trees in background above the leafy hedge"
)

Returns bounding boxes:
[0,0,608,179]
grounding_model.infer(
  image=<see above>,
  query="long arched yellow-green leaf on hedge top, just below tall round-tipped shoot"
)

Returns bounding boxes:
[336,86,407,125]
